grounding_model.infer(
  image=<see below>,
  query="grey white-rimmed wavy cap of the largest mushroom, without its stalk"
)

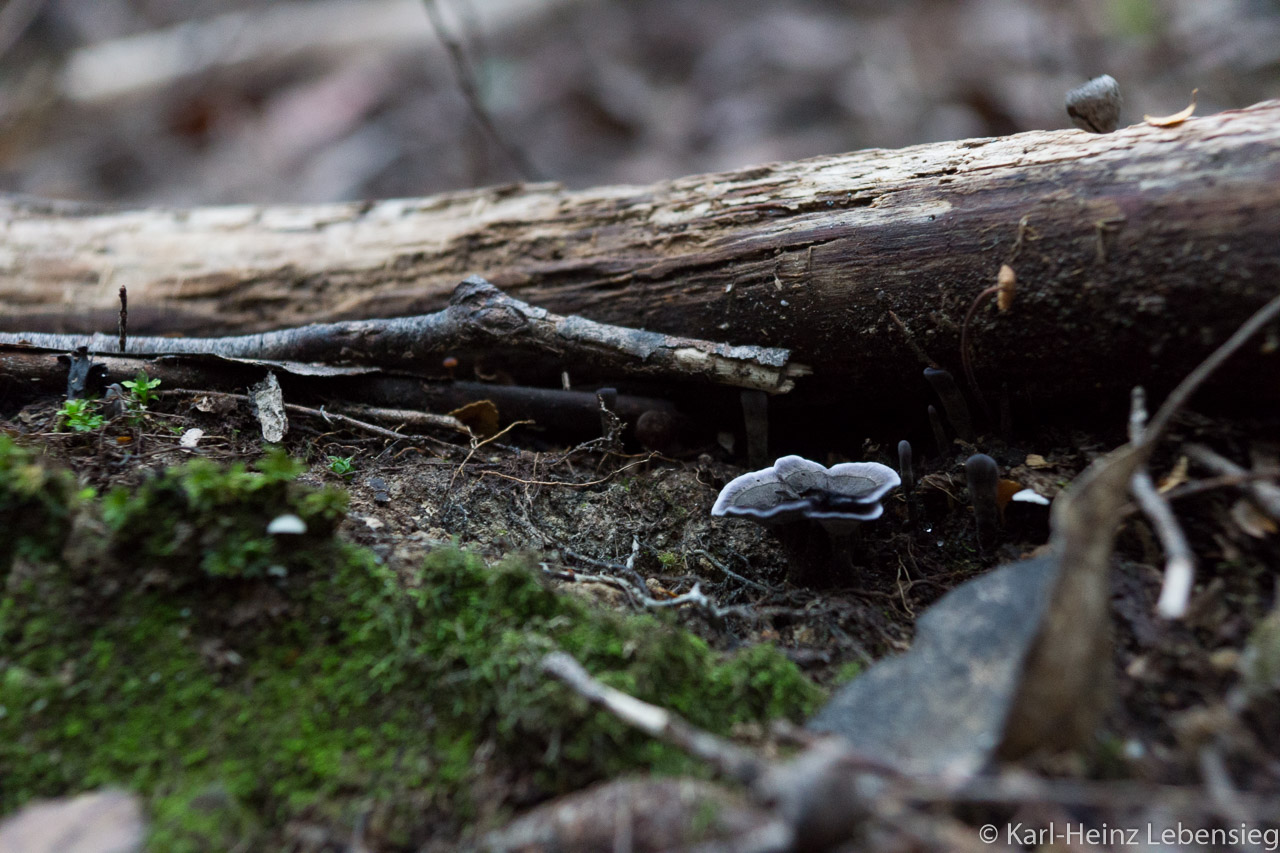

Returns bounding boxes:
[712,456,901,526]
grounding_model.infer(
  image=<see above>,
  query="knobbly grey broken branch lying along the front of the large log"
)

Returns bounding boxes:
[0,277,808,393]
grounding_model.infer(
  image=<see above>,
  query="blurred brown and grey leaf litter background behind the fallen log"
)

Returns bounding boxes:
[0,0,1280,205]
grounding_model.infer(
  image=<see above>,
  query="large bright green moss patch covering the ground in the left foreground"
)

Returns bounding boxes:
[0,450,819,853]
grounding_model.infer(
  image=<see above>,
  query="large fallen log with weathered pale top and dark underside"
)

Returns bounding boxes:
[0,101,1280,407]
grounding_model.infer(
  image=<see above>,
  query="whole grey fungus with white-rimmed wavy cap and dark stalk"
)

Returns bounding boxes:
[712,456,901,583]
